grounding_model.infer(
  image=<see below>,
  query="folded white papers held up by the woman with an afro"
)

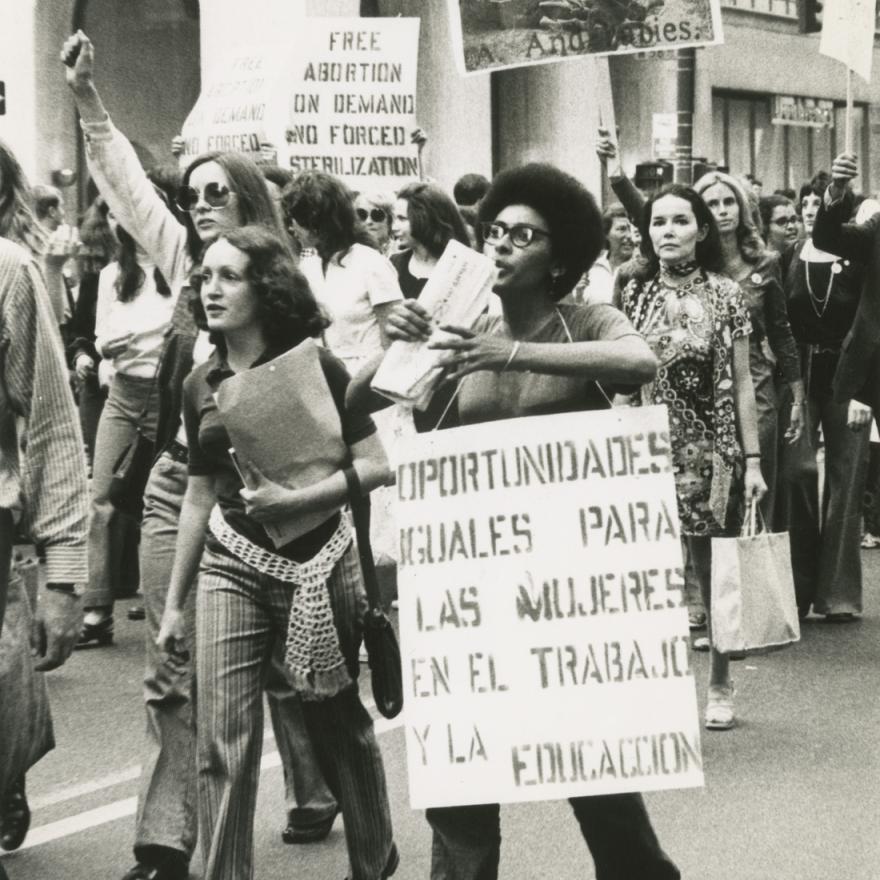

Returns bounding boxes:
[372,241,495,410]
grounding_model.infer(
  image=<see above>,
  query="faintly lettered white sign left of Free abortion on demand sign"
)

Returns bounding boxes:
[180,45,285,167]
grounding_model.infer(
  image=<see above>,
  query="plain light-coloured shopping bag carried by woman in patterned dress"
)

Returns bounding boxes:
[710,508,801,654]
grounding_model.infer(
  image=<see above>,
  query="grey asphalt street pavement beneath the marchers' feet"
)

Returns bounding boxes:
[3,550,880,880]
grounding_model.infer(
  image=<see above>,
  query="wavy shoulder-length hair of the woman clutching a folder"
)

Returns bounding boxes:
[190,225,330,351]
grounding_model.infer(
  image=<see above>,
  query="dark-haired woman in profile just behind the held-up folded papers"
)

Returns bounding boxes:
[391,183,471,299]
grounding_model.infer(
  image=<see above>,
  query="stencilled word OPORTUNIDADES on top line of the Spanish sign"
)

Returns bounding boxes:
[397,431,670,503]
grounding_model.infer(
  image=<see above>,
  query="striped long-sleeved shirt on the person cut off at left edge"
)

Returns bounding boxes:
[0,238,89,584]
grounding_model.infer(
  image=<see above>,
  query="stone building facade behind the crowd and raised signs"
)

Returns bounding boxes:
[0,0,880,217]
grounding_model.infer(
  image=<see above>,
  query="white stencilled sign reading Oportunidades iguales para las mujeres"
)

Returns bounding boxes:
[395,407,703,809]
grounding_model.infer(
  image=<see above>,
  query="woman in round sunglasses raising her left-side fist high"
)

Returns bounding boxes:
[61,31,337,880]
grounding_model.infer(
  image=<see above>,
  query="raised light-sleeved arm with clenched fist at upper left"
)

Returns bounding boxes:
[61,31,190,286]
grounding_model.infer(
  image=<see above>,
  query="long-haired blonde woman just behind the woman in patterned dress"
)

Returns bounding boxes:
[694,171,804,523]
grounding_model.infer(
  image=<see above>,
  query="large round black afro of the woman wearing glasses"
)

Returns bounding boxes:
[477,162,605,299]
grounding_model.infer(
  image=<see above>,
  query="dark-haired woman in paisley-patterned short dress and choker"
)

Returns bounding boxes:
[619,184,766,730]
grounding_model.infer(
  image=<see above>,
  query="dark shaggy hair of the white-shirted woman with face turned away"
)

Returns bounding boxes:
[281,171,378,261]
